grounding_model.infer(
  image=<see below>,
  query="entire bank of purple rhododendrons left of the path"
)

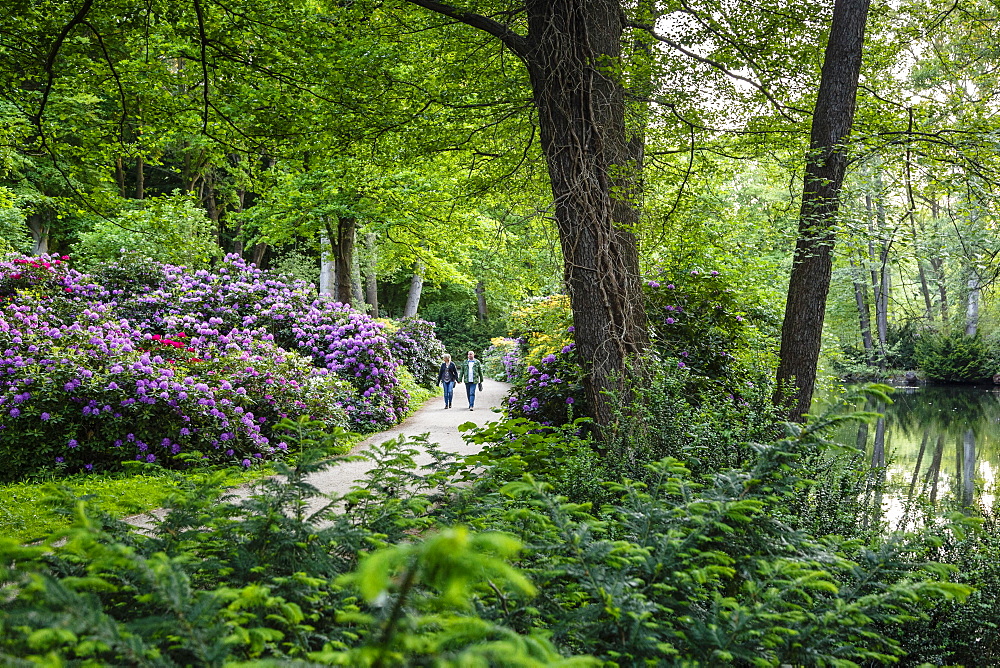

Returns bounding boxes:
[0,256,442,479]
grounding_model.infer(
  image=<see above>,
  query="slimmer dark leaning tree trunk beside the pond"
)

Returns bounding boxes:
[774,0,869,421]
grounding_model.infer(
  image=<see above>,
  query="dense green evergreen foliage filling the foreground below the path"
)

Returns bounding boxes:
[0,414,969,666]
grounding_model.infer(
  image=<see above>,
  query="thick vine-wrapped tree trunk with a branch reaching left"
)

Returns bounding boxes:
[408,0,647,428]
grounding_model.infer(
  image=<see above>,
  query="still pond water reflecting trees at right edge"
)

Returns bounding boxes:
[814,385,1000,521]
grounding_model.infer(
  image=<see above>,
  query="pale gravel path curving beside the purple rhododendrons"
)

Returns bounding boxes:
[308,380,510,494]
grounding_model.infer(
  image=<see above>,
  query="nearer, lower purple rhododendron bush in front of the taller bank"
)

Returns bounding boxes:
[0,299,351,480]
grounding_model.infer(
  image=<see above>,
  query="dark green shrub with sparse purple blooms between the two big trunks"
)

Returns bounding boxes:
[645,269,744,378]
